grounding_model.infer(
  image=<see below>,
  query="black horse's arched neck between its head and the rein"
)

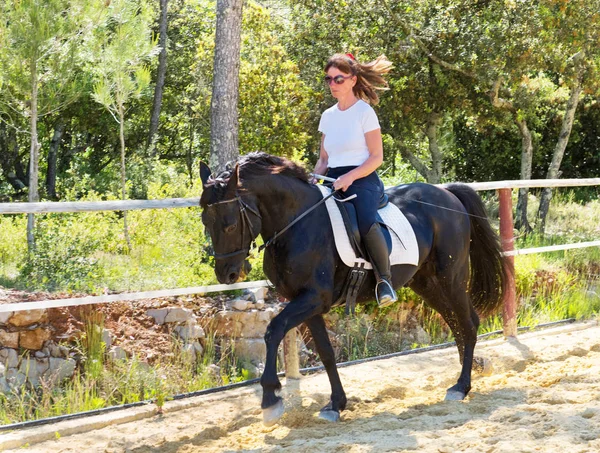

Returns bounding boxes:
[249,175,322,240]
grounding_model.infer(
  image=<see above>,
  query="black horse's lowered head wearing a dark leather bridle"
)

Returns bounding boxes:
[200,163,262,284]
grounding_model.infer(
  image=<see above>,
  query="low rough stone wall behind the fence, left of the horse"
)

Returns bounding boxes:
[0,288,282,392]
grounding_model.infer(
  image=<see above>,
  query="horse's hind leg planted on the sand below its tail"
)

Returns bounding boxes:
[411,268,479,400]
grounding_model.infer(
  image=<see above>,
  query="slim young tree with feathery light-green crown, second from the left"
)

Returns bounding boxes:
[93,0,157,250]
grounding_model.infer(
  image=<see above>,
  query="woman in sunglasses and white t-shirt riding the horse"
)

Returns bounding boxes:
[314,54,397,307]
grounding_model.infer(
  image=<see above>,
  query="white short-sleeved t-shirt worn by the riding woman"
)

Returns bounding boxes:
[319,99,380,168]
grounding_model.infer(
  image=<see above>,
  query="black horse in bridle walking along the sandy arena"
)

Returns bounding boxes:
[200,153,510,424]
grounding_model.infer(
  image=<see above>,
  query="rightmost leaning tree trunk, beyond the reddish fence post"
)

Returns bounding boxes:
[537,77,583,233]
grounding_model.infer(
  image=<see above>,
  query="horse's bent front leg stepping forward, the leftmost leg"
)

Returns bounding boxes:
[260,290,322,426]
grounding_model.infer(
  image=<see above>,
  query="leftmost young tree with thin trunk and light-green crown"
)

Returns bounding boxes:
[0,0,102,251]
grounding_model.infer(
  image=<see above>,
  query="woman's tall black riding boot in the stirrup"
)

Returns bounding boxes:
[363,223,398,307]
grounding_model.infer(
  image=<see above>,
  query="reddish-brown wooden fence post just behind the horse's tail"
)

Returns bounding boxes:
[498,189,517,337]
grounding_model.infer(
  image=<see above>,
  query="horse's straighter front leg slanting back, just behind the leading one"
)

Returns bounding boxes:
[304,315,347,422]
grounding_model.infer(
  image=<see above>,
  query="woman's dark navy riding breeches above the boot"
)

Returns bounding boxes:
[327,166,383,237]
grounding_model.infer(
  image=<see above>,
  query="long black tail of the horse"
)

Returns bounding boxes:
[445,184,513,316]
